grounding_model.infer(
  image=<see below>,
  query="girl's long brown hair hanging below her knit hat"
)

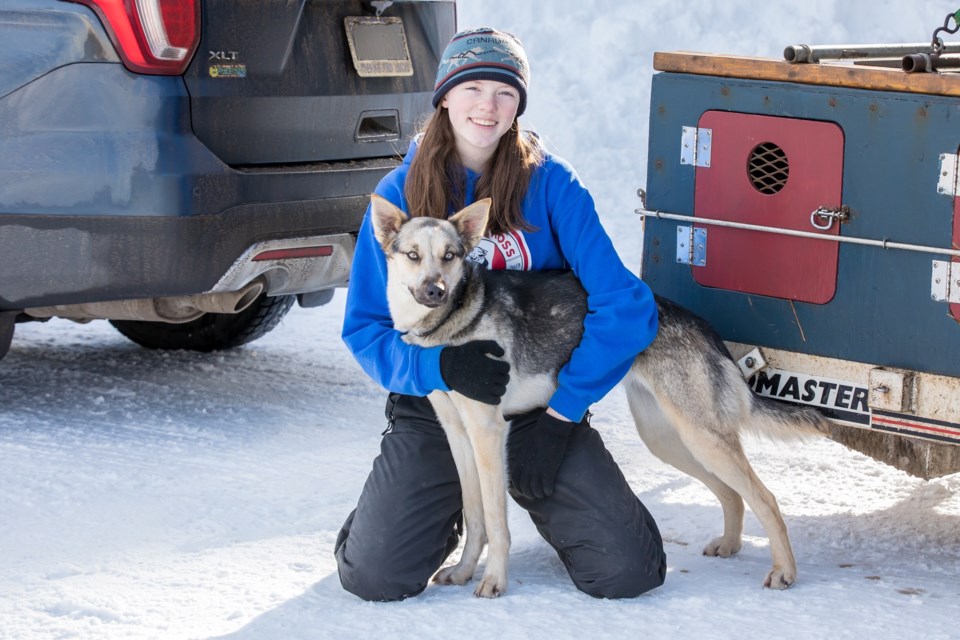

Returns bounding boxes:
[404,106,543,234]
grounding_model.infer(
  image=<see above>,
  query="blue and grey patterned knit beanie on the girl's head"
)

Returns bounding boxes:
[433,27,530,116]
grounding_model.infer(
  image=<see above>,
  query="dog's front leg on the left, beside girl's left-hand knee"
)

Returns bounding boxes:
[430,393,487,585]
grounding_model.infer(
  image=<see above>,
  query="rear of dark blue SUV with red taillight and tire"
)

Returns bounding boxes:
[0,0,456,357]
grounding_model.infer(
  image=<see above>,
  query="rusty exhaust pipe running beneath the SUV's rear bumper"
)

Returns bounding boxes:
[24,278,265,324]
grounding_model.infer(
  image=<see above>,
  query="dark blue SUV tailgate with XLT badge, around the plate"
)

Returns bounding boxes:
[185,0,456,166]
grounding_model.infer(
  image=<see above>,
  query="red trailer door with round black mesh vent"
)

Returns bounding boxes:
[693,111,843,304]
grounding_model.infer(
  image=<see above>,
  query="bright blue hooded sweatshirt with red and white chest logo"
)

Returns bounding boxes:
[342,143,657,421]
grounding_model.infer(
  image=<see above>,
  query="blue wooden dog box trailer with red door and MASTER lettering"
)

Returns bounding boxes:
[638,31,960,478]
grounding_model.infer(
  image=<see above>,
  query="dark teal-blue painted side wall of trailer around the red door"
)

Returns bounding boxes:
[643,73,960,376]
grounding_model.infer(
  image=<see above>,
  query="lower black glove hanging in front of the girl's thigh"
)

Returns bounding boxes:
[507,411,586,499]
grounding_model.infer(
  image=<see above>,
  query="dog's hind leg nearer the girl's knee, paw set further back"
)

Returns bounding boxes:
[626,381,744,558]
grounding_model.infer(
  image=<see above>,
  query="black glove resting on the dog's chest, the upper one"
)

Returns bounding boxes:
[440,340,510,404]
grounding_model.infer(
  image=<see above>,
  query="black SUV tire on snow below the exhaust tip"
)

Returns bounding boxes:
[110,294,296,352]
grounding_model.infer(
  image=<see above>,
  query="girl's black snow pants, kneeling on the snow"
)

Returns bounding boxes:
[334,394,667,601]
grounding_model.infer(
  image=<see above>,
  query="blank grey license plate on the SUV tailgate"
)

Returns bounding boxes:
[343,17,413,78]
